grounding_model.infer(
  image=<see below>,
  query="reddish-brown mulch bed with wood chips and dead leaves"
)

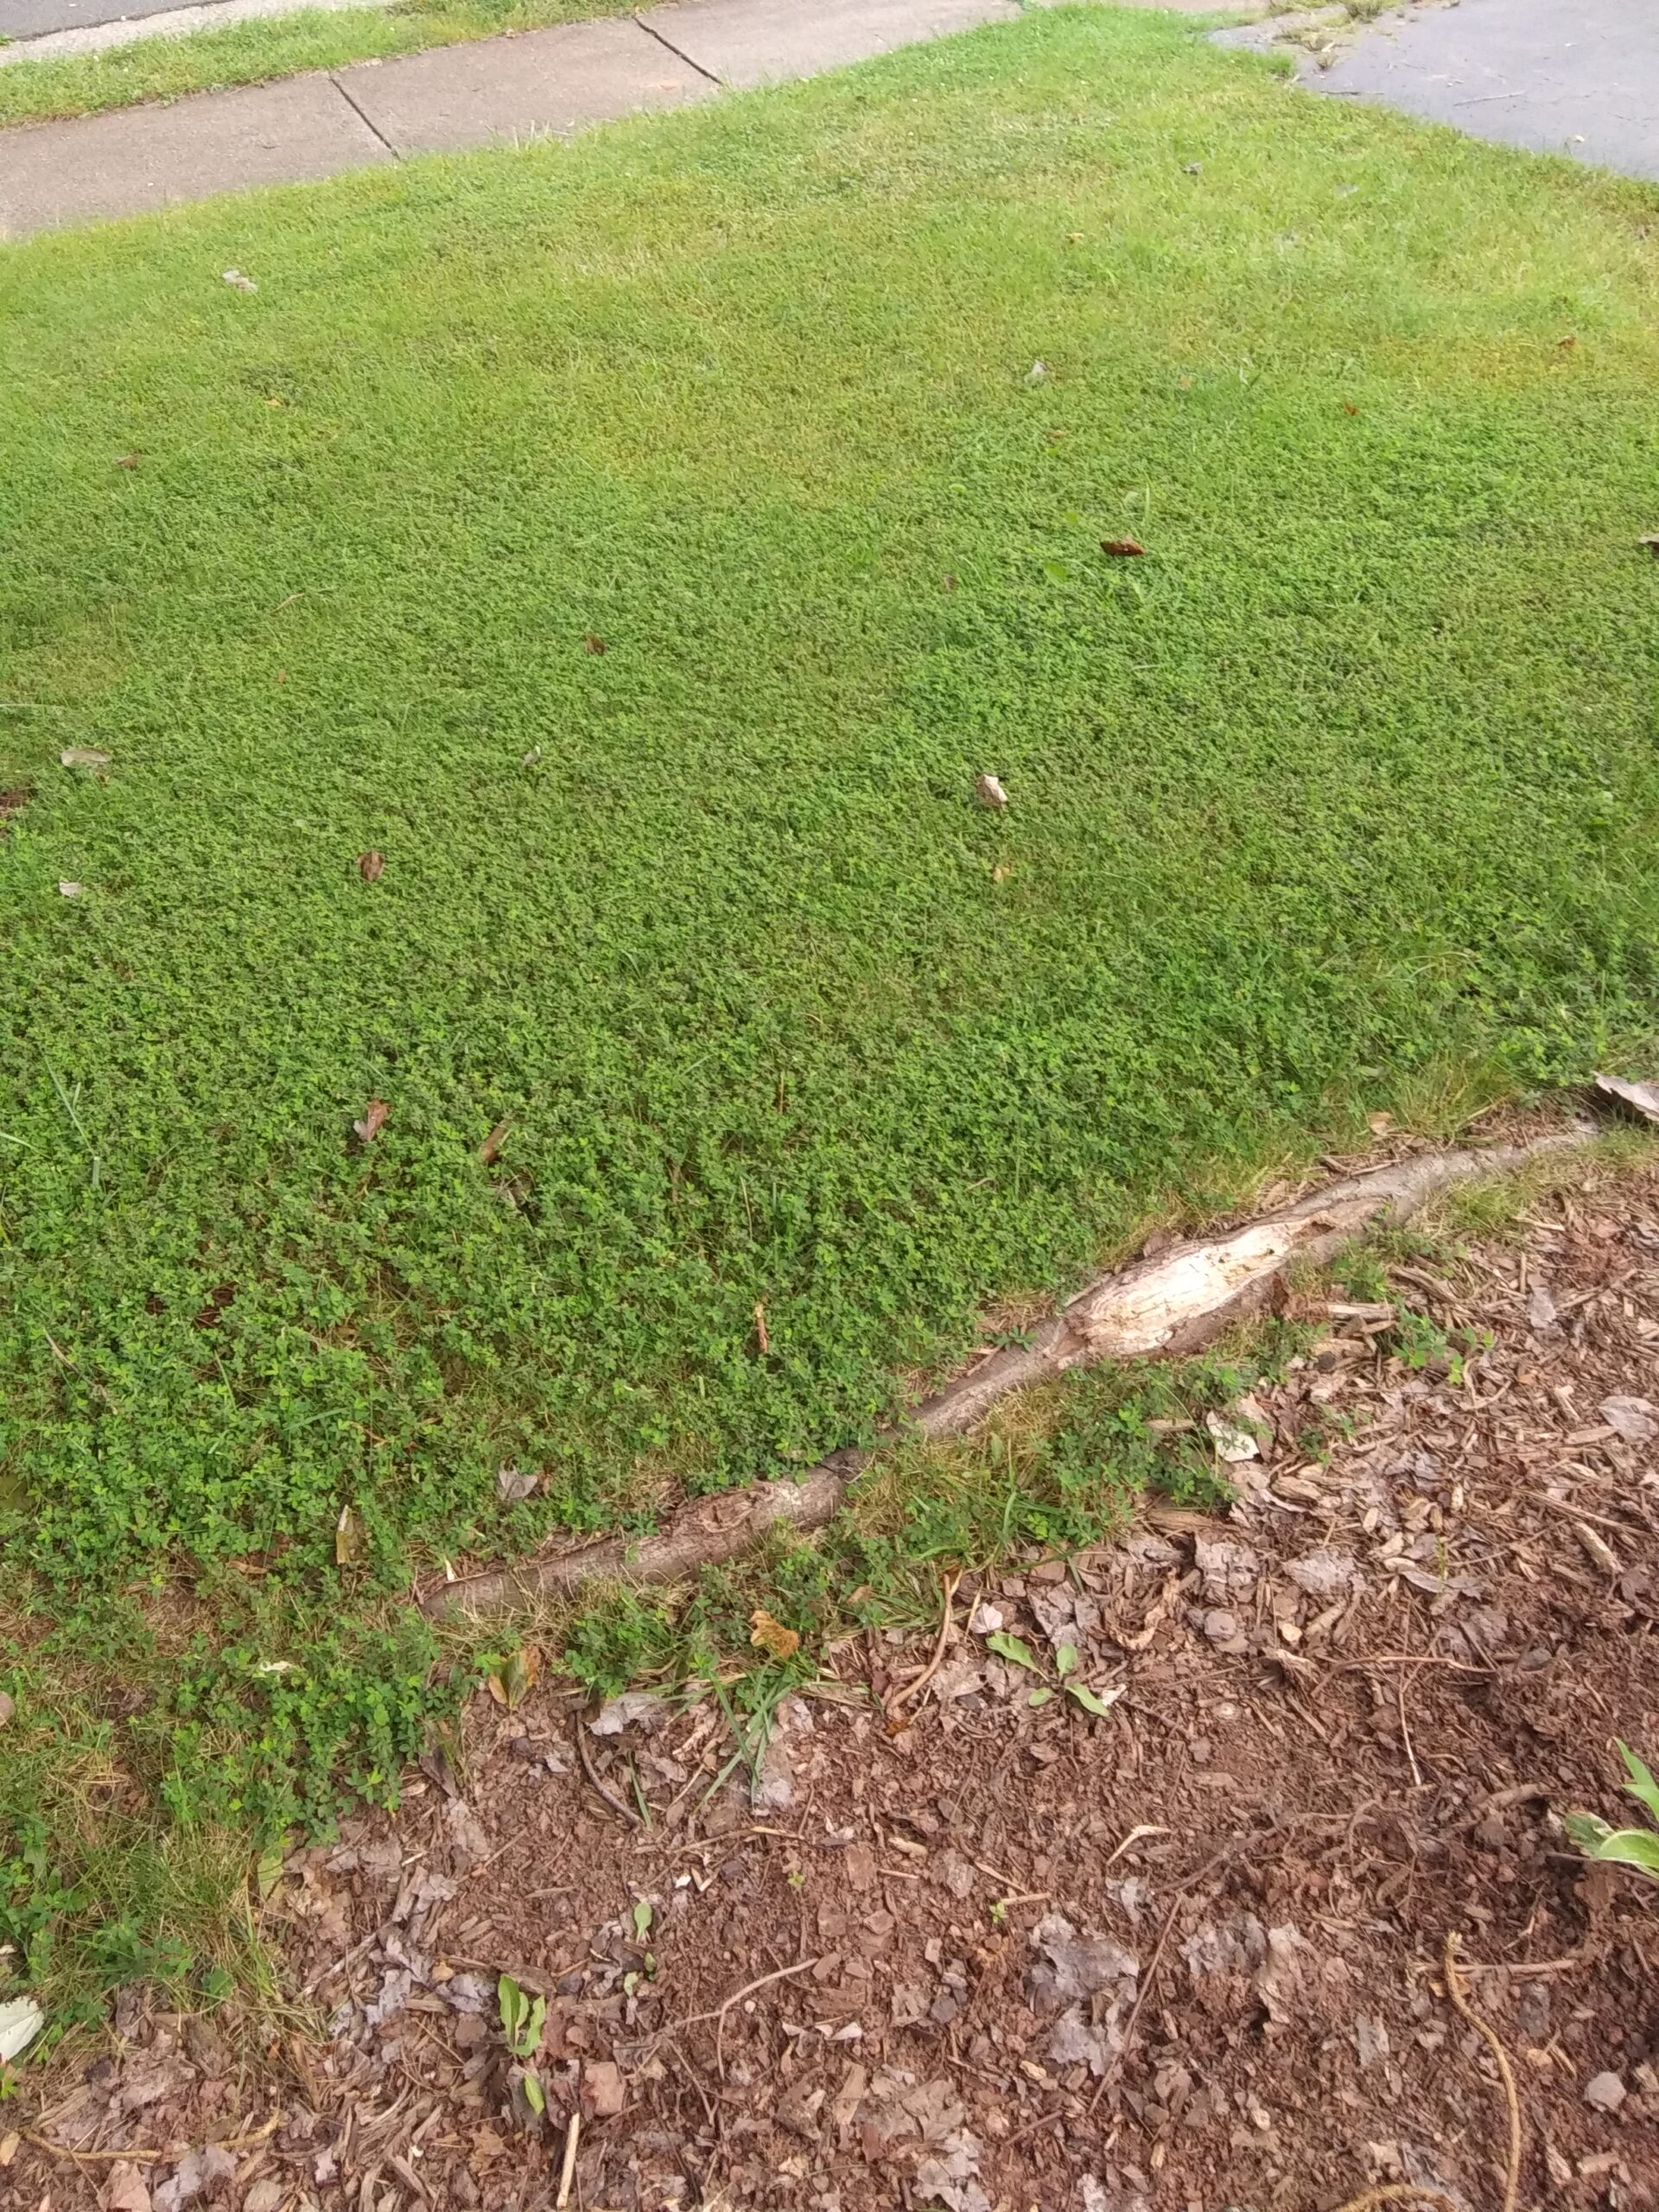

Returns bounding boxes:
[13,1174,1659,2212]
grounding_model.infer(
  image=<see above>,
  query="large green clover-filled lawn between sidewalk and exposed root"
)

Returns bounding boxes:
[0,9,1659,2025]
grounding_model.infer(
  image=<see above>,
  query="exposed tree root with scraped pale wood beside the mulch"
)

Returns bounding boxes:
[423,1122,1599,1619]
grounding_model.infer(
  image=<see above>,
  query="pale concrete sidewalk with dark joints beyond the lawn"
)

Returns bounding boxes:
[0,0,1026,238]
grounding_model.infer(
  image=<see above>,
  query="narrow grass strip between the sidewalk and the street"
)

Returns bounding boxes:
[0,0,628,126]
